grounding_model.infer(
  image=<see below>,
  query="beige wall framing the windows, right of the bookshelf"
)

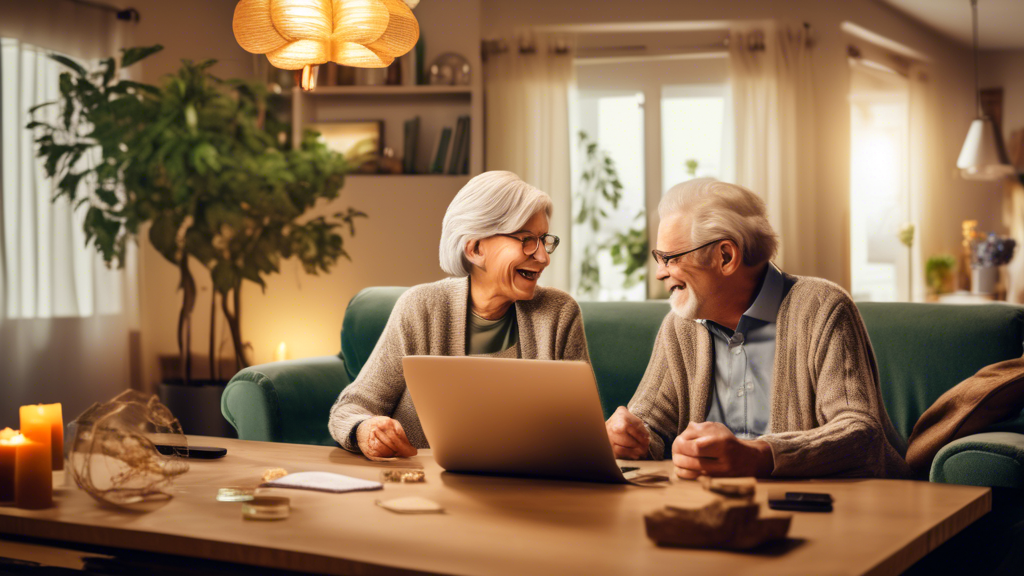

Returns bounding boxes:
[481,0,1001,288]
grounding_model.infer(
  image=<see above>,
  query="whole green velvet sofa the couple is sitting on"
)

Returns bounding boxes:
[221,288,1024,489]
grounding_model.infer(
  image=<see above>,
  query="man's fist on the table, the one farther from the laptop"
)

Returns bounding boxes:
[672,422,775,480]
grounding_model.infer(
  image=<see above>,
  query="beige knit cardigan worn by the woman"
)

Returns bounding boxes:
[328,278,590,452]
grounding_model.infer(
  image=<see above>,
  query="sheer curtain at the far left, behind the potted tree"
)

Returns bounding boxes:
[0,0,137,422]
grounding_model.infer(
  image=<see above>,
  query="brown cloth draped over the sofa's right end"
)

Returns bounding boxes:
[906,358,1024,471]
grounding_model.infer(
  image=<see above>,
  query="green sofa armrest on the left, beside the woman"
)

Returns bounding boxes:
[220,356,349,446]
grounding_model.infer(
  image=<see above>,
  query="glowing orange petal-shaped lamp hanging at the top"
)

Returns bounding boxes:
[231,0,420,90]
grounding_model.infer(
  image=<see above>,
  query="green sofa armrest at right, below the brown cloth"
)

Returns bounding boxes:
[930,431,1024,488]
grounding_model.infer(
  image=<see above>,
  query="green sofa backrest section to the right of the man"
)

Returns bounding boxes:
[857,302,1024,439]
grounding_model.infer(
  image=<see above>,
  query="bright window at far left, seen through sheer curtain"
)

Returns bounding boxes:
[0,38,124,319]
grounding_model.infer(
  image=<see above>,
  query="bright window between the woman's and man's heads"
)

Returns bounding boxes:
[571,53,732,300]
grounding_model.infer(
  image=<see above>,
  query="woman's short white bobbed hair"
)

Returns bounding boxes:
[439,170,551,278]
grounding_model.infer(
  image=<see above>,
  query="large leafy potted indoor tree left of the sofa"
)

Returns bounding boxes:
[29,46,365,434]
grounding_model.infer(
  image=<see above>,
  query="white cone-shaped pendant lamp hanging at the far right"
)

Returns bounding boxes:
[956,0,1014,180]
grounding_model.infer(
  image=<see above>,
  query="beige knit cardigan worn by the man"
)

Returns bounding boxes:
[629,275,910,478]
